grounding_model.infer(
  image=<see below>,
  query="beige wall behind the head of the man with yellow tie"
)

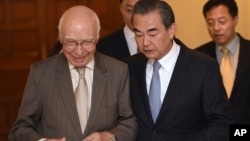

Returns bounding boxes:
[165,0,250,48]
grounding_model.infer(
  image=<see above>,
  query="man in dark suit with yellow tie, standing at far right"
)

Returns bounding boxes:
[197,0,250,124]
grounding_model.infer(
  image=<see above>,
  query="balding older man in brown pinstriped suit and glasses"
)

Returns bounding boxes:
[9,6,137,141]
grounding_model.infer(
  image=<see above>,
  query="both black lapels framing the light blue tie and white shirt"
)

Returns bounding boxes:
[133,51,191,128]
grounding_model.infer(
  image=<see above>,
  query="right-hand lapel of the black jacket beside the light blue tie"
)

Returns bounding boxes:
[156,47,191,124]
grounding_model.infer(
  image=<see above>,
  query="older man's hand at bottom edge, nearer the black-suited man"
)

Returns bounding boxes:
[83,131,113,141]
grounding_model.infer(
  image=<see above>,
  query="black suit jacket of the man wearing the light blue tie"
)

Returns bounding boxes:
[125,45,231,141]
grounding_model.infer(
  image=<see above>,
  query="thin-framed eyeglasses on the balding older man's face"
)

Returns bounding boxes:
[62,39,96,50]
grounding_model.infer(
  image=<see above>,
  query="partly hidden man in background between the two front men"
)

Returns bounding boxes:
[97,0,138,60]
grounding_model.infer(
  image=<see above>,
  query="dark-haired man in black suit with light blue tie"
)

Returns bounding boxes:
[125,0,231,141]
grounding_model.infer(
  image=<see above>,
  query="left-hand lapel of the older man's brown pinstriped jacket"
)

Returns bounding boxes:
[56,55,82,135]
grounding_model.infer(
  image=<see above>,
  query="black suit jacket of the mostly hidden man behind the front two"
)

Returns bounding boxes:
[96,28,130,60]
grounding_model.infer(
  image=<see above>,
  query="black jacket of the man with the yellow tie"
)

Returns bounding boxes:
[197,34,250,124]
